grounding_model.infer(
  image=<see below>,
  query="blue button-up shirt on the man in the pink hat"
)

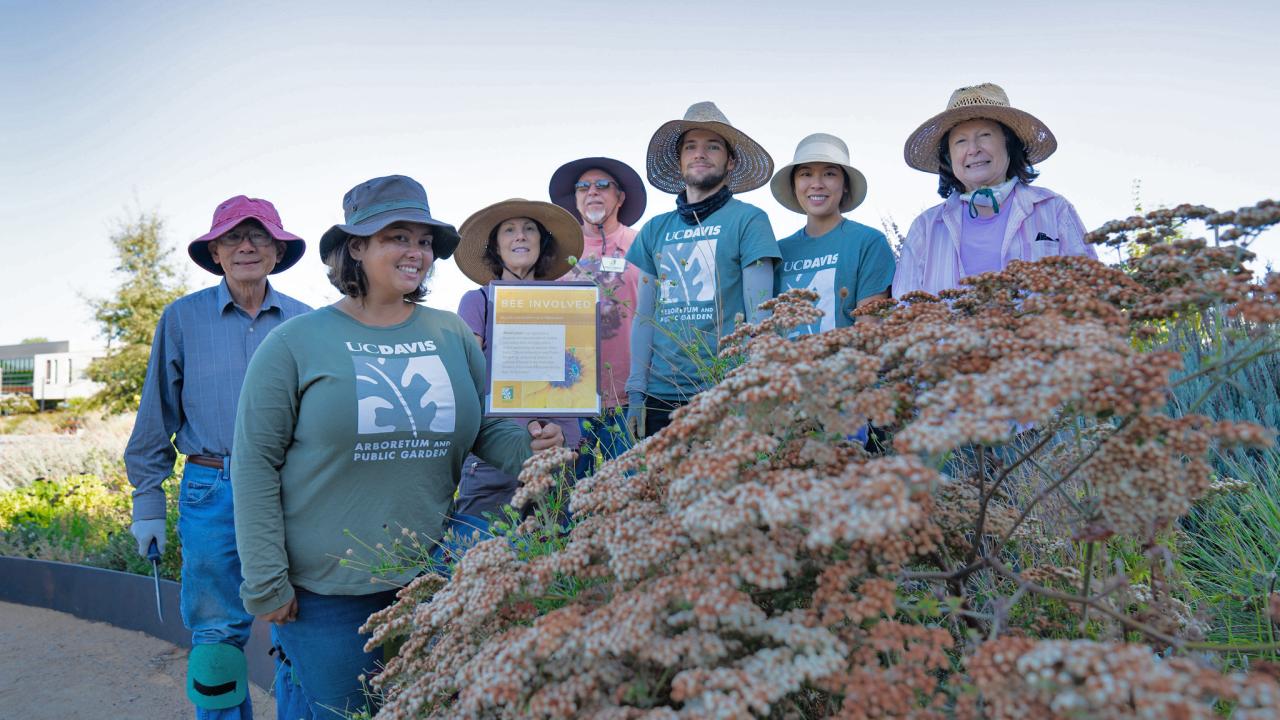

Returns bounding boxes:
[124,279,311,520]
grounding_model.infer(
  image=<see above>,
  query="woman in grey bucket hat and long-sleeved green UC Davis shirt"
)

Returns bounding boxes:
[232,176,563,719]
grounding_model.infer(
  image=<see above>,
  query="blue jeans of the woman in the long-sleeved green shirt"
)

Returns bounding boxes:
[276,587,396,720]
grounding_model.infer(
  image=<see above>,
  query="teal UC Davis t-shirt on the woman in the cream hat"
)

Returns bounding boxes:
[774,218,895,336]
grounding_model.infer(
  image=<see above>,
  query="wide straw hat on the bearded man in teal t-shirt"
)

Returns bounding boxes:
[645,102,773,195]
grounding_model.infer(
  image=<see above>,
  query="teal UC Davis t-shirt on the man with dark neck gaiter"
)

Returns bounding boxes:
[627,193,780,401]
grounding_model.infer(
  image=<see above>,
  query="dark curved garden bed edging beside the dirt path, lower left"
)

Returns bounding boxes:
[0,555,275,691]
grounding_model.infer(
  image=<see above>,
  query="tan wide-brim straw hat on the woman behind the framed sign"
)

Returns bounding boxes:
[453,197,582,286]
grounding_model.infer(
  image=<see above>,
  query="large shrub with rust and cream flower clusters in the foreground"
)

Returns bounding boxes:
[369,201,1280,717]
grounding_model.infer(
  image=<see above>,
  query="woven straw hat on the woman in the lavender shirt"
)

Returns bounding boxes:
[902,82,1057,173]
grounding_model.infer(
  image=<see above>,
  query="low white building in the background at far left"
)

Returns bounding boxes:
[0,340,102,409]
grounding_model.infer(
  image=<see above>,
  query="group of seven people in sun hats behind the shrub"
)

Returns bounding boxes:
[125,85,1093,719]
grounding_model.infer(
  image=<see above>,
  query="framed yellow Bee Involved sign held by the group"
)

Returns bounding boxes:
[485,281,602,418]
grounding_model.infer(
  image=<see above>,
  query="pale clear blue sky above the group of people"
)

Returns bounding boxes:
[0,0,1280,343]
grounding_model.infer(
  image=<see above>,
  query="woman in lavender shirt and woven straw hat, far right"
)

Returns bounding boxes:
[893,83,1097,297]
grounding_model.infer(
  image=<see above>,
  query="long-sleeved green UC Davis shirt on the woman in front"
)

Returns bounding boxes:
[232,306,530,615]
